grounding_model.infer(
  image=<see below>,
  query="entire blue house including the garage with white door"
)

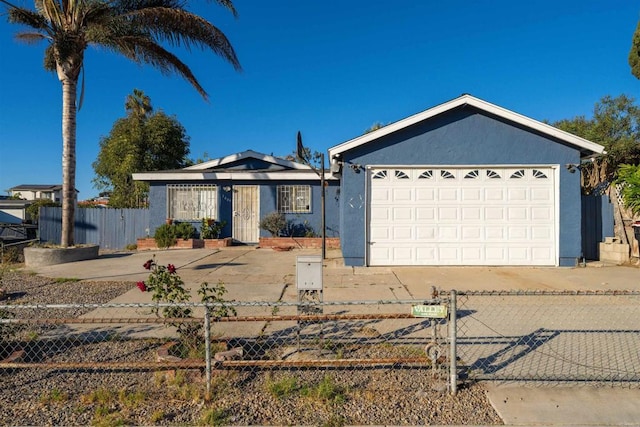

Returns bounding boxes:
[134,95,604,266]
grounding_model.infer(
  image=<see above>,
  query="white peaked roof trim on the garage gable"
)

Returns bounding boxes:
[329,95,604,159]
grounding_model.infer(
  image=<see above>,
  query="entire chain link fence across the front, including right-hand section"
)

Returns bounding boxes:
[0,291,640,393]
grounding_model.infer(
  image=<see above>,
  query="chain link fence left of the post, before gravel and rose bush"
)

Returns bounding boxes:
[0,300,449,392]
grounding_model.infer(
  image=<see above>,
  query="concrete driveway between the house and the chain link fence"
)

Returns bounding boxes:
[27,246,640,301]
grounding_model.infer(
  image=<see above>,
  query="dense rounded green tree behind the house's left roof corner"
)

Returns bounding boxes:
[93,89,189,208]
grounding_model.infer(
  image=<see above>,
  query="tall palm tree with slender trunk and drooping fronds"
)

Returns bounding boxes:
[0,0,240,247]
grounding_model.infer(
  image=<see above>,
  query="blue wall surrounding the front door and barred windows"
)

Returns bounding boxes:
[149,180,340,241]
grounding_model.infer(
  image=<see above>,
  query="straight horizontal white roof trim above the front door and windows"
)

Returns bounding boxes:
[133,171,337,181]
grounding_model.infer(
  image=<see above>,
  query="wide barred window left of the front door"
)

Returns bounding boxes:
[167,184,218,220]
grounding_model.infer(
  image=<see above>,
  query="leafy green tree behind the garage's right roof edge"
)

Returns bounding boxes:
[554,95,640,193]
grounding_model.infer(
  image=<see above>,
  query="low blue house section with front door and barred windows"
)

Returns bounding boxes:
[133,150,339,243]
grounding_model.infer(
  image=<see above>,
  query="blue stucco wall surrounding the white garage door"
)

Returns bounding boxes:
[340,107,581,266]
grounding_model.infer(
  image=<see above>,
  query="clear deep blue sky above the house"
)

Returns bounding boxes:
[0,0,640,200]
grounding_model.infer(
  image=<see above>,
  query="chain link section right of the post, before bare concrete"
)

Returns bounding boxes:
[456,291,640,387]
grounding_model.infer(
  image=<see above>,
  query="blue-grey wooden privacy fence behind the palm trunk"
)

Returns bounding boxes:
[38,207,149,249]
